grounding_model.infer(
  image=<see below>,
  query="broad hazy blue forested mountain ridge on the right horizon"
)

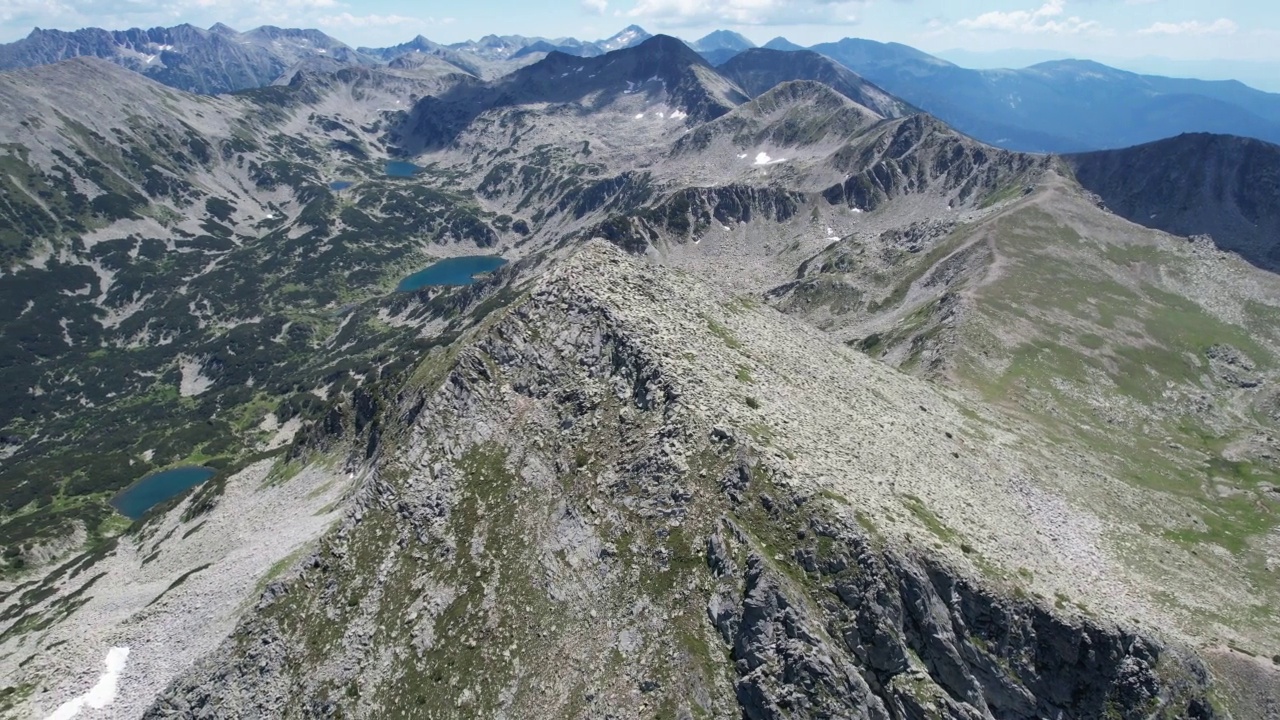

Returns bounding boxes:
[813,38,1280,152]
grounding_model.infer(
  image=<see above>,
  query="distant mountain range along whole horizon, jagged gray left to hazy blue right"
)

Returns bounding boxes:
[0,24,1280,152]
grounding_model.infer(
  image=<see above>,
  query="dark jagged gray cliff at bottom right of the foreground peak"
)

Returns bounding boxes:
[708,501,1213,719]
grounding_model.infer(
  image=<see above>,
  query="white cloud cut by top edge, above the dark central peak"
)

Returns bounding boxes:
[626,0,867,27]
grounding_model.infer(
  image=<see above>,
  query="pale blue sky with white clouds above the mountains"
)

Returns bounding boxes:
[0,0,1280,77]
